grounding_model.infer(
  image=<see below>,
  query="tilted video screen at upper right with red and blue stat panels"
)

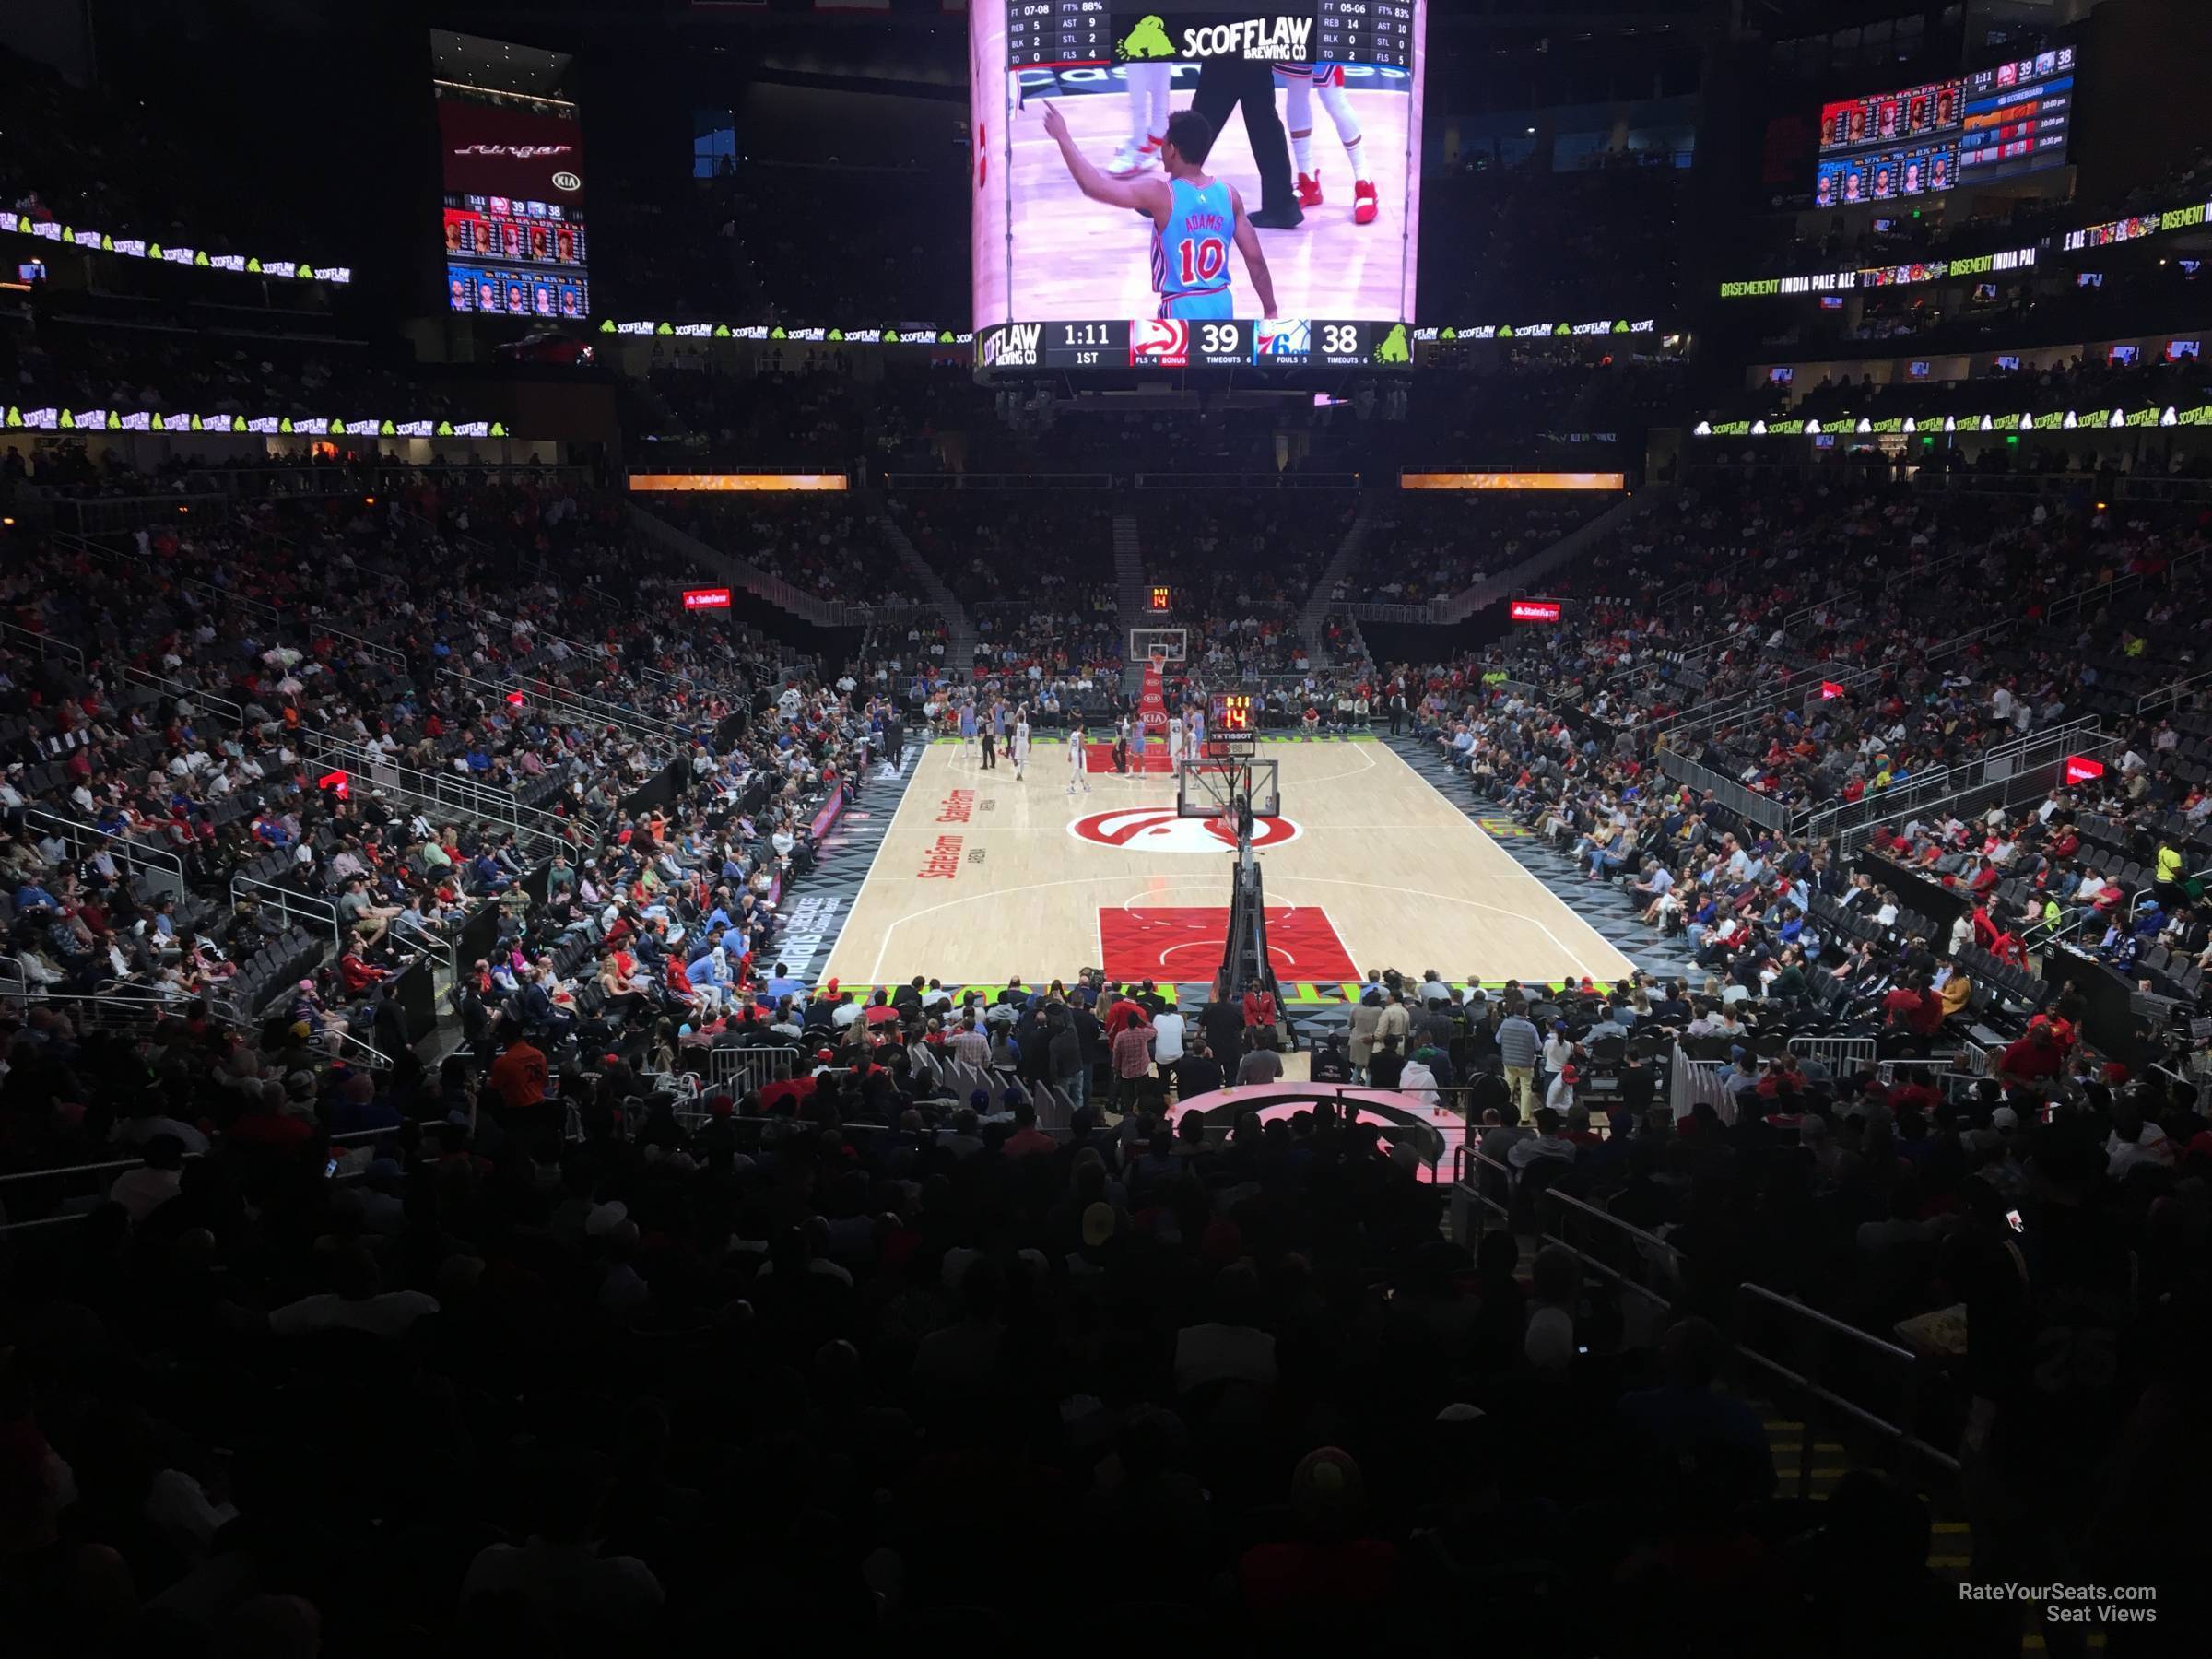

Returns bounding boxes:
[1814,46,2075,208]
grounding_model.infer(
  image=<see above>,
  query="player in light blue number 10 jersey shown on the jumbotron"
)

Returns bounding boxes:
[1044,101,1274,319]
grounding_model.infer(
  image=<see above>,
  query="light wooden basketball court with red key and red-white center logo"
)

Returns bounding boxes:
[825,732,1632,1005]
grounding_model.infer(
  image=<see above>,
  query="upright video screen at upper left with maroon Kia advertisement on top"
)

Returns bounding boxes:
[438,88,591,321]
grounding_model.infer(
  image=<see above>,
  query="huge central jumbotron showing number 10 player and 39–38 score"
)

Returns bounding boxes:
[969,0,1429,371]
